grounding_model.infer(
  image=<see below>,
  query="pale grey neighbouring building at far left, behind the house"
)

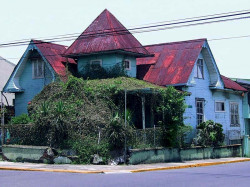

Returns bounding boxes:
[0,57,15,105]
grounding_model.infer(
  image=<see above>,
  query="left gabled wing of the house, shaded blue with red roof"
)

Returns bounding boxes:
[3,40,76,116]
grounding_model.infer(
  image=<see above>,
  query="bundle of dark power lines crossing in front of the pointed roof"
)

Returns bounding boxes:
[0,11,250,47]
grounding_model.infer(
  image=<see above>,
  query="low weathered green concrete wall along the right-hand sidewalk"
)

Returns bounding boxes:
[129,145,242,164]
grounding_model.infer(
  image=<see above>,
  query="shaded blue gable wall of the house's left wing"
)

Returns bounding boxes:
[15,60,53,116]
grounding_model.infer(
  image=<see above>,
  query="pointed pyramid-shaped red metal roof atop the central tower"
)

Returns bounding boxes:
[65,9,149,56]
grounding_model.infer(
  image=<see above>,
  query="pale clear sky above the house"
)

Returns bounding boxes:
[0,0,250,78]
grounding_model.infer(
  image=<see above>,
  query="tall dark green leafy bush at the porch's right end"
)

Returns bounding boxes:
[156,86,186,147]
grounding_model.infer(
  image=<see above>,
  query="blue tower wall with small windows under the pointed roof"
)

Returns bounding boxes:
[77,54,136,77]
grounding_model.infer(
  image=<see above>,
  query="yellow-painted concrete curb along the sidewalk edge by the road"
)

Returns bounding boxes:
[0,158,250,174]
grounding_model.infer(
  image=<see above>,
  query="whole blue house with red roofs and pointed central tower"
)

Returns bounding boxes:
[4,10,247,143]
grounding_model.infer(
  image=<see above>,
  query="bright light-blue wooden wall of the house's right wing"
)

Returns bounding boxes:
[184,51,245,143]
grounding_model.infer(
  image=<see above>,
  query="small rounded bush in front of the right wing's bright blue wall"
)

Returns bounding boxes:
[196,120,225,146]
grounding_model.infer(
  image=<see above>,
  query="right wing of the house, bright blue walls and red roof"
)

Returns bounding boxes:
[137,39,247,143]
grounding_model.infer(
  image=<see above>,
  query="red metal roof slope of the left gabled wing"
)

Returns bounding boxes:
[32,40,76,77]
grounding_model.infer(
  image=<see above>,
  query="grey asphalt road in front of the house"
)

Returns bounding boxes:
[0,162,250,187]
